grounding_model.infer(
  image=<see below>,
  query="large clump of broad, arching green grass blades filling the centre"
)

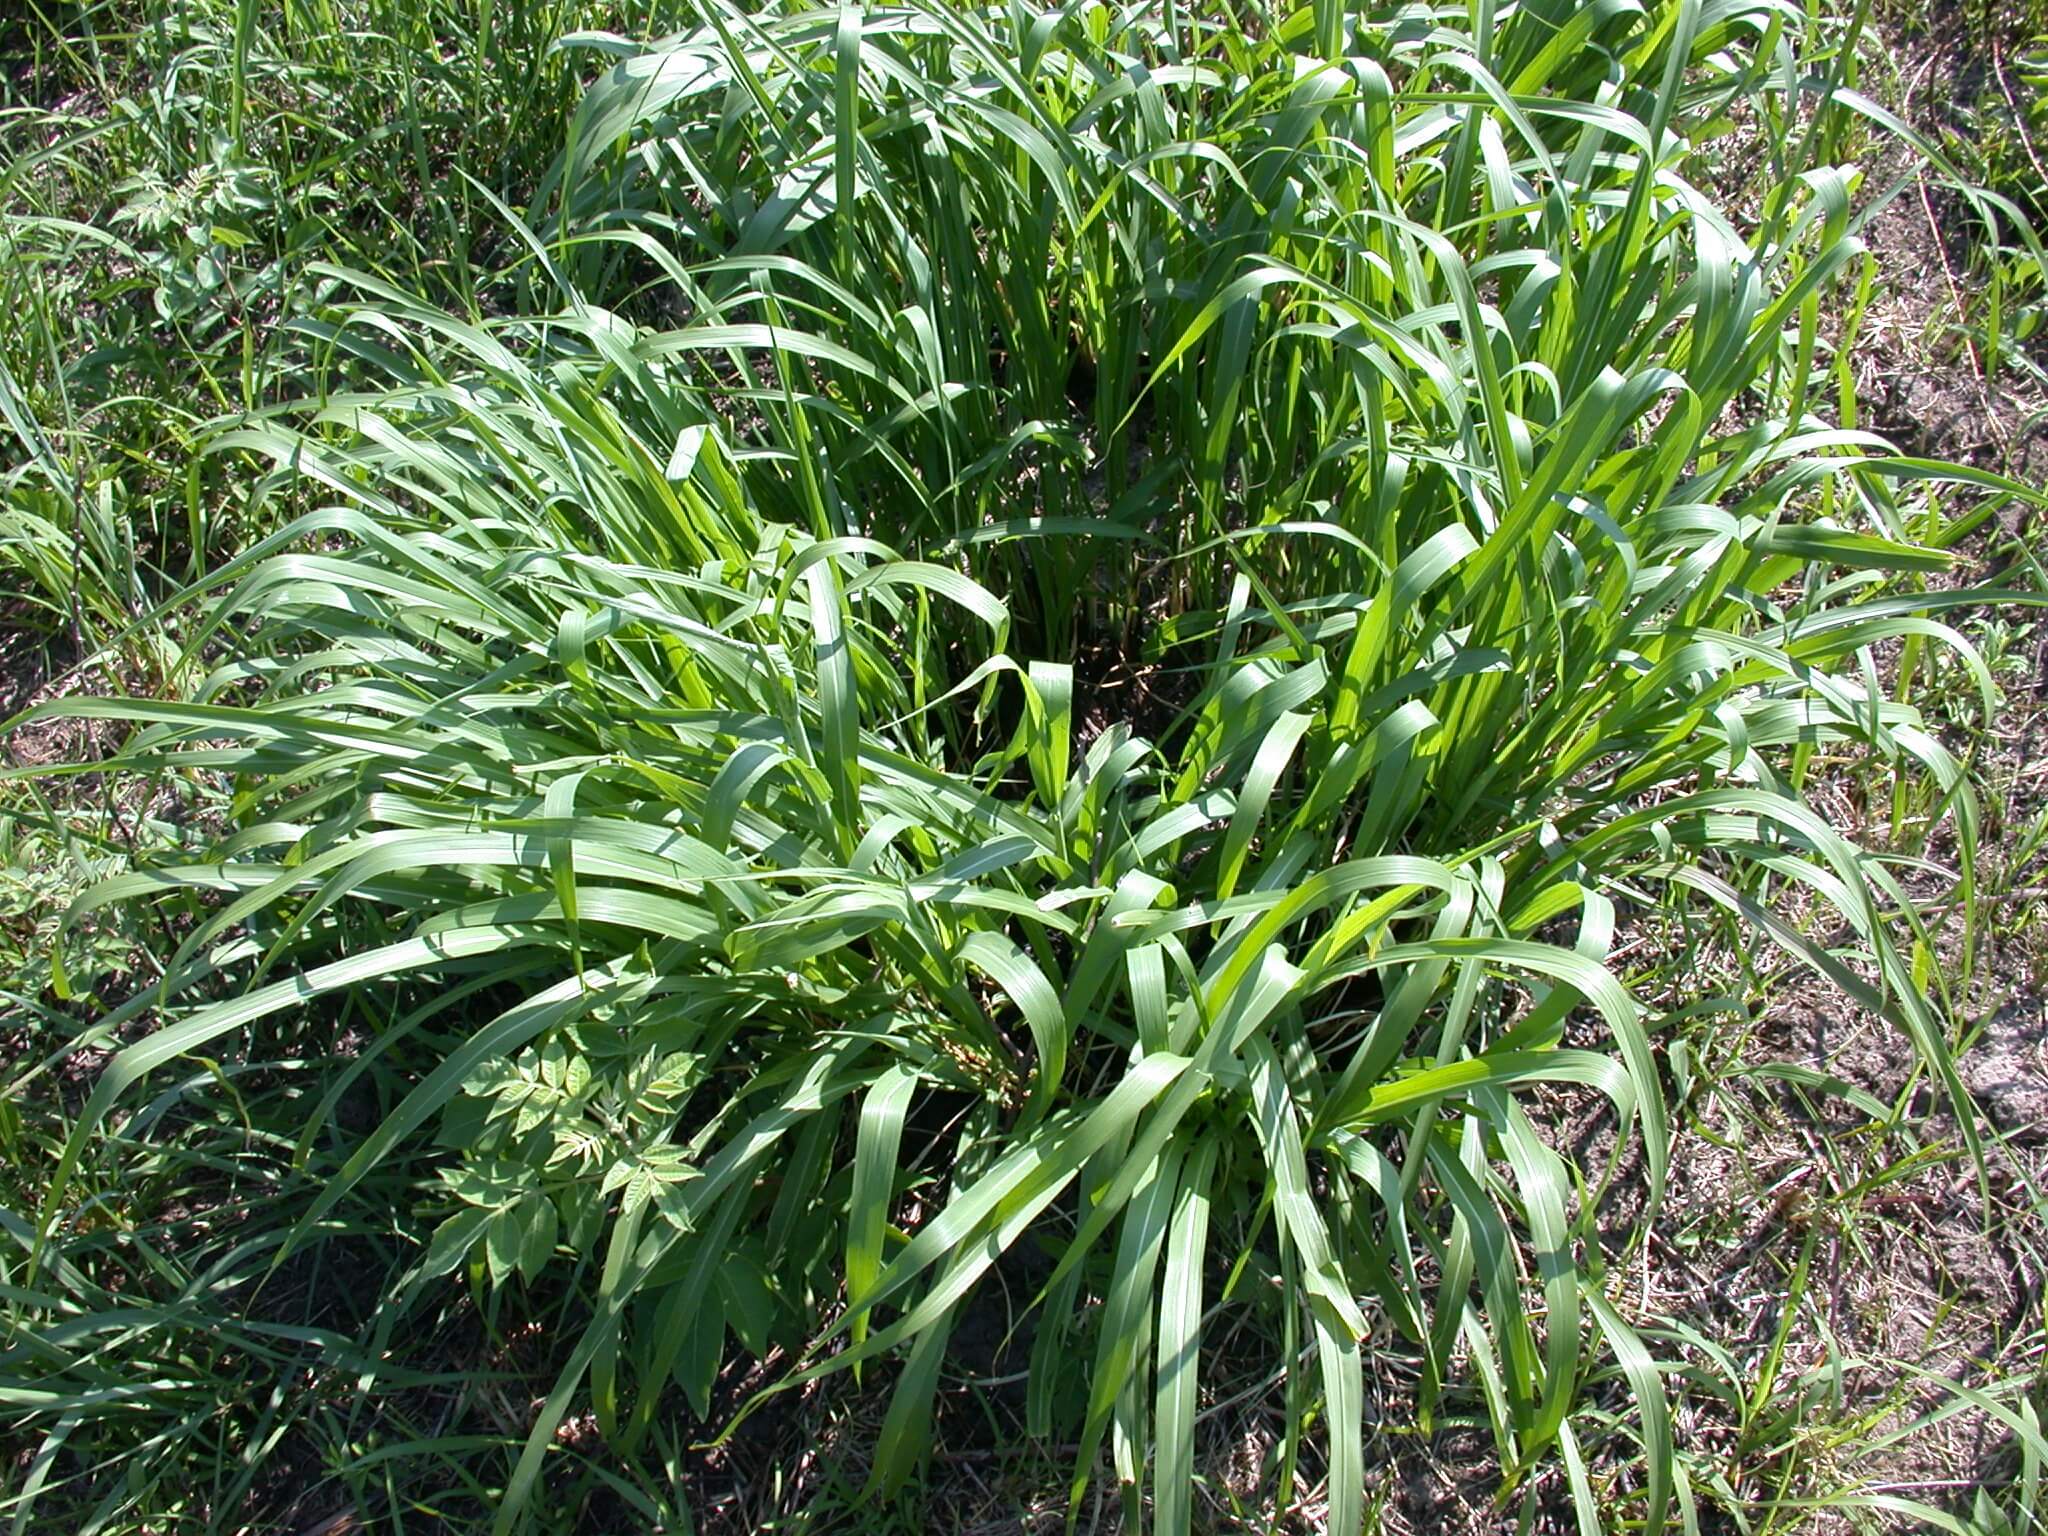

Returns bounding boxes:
[6,0,2038,1532]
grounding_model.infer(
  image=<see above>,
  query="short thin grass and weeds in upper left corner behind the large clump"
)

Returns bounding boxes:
[0,0,618,668]
